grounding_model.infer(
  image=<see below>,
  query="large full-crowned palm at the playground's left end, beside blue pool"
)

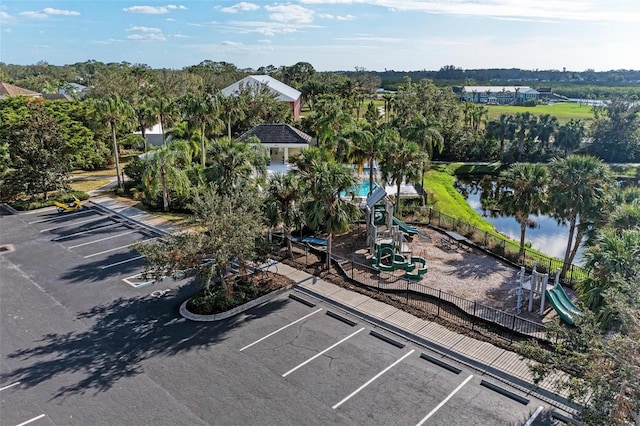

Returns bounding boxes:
[299,161,360,268]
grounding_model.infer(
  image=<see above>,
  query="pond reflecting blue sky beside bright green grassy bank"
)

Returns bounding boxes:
[456,177,583,265]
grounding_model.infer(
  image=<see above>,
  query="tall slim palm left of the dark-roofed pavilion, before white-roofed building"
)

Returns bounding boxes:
[182,93,224,167]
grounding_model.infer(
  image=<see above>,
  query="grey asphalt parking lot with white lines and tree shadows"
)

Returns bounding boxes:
[0,205,546,425]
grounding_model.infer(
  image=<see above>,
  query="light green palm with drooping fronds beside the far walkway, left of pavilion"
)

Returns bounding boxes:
[143,142,191,212]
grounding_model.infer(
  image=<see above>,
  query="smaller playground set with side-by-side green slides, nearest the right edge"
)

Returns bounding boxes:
[516,263,582,325]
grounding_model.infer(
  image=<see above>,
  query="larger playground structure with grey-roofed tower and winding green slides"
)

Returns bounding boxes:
[366,188,428,281]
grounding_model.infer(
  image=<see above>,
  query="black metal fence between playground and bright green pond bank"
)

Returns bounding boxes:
[416,208,589,286]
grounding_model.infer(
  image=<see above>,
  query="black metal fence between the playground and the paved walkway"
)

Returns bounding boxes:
[277,238,548,342]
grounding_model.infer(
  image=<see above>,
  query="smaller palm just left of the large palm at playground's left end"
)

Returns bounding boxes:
[264,173,304,258]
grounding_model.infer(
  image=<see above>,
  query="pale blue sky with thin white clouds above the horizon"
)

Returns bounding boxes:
[0,0,640,71]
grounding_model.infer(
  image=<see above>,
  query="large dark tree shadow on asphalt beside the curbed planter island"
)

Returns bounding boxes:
[0,285,288,399]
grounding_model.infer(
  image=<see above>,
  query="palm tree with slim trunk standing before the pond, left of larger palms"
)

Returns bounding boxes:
[498,164,549,259]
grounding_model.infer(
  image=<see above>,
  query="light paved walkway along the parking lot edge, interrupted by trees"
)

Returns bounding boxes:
[90,196,575,413]
